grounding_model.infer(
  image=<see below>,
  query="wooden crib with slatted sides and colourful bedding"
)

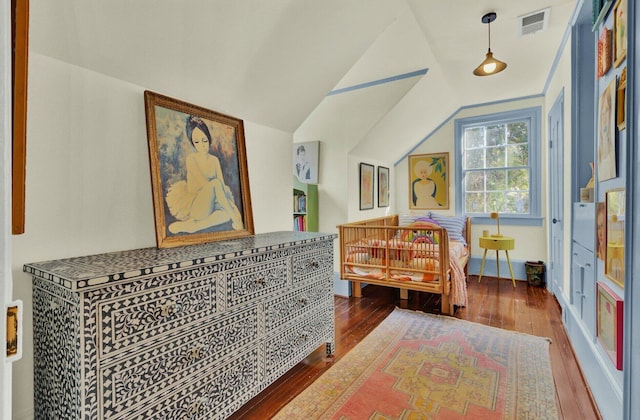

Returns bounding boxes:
[338,215,471,314]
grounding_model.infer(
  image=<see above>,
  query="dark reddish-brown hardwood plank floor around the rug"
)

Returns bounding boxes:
[231,276,601,420]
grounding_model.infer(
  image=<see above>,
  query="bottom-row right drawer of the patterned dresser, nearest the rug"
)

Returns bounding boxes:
[265,307,334,381]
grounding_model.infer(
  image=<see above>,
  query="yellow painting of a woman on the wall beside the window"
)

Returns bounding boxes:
[408,153,449,210]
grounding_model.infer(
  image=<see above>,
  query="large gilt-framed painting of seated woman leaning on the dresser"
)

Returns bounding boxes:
[144,91,254,248]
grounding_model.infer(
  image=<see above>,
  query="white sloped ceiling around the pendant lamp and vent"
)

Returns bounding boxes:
[30,0,577,159]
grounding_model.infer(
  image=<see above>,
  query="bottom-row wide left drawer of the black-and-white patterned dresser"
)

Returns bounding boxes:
[126,347,262,420]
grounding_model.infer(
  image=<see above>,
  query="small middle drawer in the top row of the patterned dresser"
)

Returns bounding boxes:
[222,254,291,308]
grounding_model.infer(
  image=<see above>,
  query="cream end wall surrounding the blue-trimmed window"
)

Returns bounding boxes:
[394,97,547,260]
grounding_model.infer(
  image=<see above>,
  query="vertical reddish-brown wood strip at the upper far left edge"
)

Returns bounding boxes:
[11,0,29,235]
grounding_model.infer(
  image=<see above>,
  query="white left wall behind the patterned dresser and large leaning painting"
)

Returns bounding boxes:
[12,53,292,419]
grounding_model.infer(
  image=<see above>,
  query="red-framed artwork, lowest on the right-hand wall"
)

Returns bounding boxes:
[596,282,624,370]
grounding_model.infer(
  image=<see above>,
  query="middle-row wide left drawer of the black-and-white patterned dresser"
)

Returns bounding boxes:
[99,307,258,418]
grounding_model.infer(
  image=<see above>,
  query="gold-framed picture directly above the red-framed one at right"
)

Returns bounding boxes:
[604,188,625,287]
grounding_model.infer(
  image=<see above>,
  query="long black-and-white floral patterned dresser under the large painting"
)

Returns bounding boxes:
[24,232,335,419]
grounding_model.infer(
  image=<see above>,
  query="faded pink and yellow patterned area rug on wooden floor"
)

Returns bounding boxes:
[274,308,558,420]
